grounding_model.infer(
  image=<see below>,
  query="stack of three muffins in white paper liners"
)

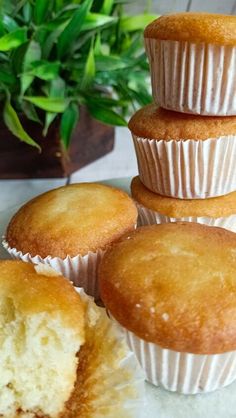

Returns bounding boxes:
[129,13,236,231]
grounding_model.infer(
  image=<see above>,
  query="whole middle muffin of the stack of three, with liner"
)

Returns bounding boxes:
[128,104,236,199]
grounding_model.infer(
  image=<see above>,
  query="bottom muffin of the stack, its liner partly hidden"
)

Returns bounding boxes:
[131,176,236,232]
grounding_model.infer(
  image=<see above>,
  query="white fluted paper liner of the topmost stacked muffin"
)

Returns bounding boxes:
[145,38,236,116]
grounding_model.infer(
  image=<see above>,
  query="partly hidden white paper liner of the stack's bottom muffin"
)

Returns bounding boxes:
[136,202,236,232]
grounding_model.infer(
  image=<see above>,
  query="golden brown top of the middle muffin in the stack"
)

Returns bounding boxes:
[128,104,236,141]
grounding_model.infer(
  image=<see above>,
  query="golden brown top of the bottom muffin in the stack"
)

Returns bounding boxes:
[131,176,236,218]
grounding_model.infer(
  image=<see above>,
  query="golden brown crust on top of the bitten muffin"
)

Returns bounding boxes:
[0,260,85,339]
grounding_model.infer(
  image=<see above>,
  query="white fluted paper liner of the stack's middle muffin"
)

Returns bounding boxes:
[133,134,236,199]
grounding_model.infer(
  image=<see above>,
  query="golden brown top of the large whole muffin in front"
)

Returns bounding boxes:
[99,222,236,354]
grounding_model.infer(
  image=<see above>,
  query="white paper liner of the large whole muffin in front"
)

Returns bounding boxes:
[114,325,236,395]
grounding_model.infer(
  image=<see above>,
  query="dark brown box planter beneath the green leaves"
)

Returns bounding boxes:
[0,109,114,179]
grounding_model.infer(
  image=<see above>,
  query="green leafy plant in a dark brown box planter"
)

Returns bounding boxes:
[0,0,154,178]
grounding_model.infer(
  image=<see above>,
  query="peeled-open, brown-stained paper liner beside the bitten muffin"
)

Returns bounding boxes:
[63,289,145,418]
